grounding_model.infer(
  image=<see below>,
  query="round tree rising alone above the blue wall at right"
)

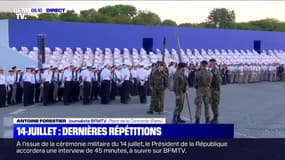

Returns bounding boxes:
[207,8,235,28]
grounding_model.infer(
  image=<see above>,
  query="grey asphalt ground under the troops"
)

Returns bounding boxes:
[0,82,285,138]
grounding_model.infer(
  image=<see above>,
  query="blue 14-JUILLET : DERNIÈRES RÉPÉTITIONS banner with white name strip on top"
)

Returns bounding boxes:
[13,118,234,139]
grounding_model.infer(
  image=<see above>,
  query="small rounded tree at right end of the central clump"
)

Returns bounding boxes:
[133,11,161,25]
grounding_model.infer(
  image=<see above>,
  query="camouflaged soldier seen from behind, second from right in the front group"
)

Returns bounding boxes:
[195,61,213,124]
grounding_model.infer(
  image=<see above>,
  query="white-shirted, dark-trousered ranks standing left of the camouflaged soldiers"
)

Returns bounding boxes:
[0,65,151,107]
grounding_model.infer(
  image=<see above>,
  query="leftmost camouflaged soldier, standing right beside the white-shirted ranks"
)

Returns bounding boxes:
[147,63,168,114]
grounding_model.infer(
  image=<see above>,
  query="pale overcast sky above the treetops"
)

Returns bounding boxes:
[0,0,285,23]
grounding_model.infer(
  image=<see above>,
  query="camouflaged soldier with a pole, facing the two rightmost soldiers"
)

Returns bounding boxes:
[173,63,188,123]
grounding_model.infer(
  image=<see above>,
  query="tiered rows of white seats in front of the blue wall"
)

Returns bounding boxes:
[12,46,285,68]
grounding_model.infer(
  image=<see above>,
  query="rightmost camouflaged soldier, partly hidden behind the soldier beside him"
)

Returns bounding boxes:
[207,59,222,124]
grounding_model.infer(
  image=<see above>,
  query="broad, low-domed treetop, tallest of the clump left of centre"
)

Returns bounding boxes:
[98,5,137,18]
